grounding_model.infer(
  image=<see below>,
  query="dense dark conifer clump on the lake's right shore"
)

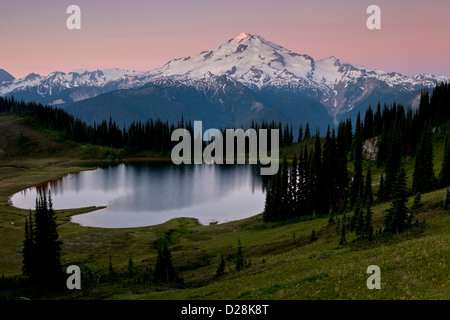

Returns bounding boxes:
[264,128,349,221]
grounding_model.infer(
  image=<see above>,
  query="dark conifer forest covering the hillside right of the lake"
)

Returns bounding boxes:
[263,83,450,238]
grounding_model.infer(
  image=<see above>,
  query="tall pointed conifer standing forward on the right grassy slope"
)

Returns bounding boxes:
[384,165,408,234]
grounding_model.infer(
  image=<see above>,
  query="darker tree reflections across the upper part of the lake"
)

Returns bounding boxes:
[17,163,269,212]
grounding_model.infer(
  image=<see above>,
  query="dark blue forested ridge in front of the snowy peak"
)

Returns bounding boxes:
[63,75,296,127]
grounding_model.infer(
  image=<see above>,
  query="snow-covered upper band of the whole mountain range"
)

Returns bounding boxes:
[0,32,450,119]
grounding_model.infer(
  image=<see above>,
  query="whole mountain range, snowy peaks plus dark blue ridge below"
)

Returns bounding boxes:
[0,33,450,128]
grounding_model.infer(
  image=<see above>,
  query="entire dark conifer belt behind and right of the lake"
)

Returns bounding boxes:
[5,83,450,230]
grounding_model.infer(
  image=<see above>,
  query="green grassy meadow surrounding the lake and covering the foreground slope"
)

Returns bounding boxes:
[0,117,450,300]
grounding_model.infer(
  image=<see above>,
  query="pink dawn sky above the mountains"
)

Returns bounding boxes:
[0,0,450,77]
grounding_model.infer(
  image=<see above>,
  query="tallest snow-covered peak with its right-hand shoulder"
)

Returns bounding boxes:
[142,33,450,114]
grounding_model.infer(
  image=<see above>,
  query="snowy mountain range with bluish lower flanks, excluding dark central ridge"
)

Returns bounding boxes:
[0,33,450,127]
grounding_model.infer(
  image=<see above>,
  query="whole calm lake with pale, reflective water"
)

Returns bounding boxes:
[10,163,265,228]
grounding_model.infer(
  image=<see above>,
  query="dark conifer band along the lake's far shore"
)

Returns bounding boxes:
[0,97,300,154]
